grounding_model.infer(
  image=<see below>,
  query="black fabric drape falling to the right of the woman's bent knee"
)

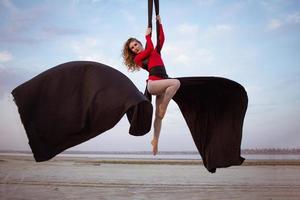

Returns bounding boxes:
[173,77,248,173]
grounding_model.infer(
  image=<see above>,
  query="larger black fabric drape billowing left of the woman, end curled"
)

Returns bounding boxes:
[12,61,153,161]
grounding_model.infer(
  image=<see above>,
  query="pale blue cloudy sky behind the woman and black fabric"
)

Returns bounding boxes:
[0,0,300,151]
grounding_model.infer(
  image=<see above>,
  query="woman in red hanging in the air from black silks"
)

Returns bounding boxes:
[123,15,180,155]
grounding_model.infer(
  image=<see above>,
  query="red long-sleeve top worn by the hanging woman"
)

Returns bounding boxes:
[134,24,165,80]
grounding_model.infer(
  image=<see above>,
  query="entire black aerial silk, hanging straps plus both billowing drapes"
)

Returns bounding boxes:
[12,0,248,173]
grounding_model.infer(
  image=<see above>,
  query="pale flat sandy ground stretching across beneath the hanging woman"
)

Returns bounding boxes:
[0,156,300,200]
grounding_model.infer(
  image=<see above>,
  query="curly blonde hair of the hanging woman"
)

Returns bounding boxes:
[122,38,142,71]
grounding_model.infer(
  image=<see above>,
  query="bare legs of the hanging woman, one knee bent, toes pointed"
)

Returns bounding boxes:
[148,79,180,155]
